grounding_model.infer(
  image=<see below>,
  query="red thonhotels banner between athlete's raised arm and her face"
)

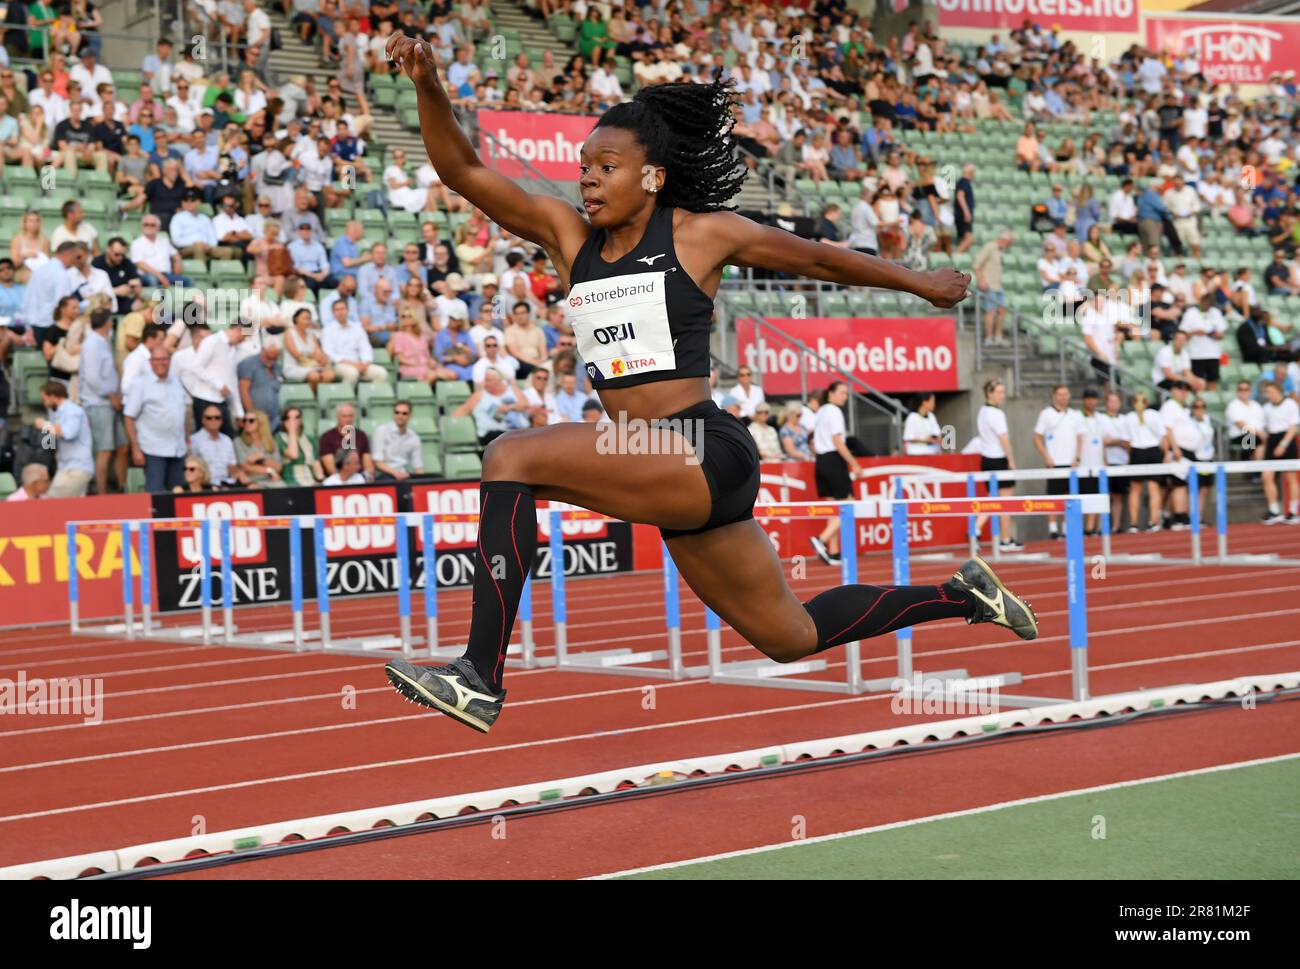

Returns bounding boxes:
[478,111,597,182]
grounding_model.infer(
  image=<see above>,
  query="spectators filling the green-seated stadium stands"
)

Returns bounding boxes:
[0,0,1300,524]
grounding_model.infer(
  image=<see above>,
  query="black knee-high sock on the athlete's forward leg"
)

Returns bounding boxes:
[465,481,537,692]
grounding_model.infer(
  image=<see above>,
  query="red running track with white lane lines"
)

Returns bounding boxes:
[0,528,1300,877]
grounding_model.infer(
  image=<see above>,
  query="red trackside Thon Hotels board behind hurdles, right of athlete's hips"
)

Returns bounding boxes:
[758,454,983,559]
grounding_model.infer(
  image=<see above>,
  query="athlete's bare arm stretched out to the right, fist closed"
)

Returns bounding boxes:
[709,212,970,307]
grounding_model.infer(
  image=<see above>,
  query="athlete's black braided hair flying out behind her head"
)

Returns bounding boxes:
[595,69,748,212]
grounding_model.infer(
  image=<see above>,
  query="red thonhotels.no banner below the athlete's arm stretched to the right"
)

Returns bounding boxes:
[736,316,958,394]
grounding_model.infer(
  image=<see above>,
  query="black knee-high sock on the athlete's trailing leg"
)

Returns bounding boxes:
[803,581,975,653]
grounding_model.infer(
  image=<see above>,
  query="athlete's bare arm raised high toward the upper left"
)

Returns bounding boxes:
[387,34,590,264]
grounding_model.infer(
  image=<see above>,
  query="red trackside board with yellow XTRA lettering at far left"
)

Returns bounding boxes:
[0,494,150,627]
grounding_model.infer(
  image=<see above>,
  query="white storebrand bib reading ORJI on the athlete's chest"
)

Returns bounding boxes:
[568,271,677,380]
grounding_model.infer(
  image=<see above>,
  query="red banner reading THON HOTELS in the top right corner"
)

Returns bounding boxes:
[1145,17,1300,85]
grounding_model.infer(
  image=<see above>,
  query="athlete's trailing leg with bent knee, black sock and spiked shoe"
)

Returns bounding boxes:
[668,520,1037,662]
